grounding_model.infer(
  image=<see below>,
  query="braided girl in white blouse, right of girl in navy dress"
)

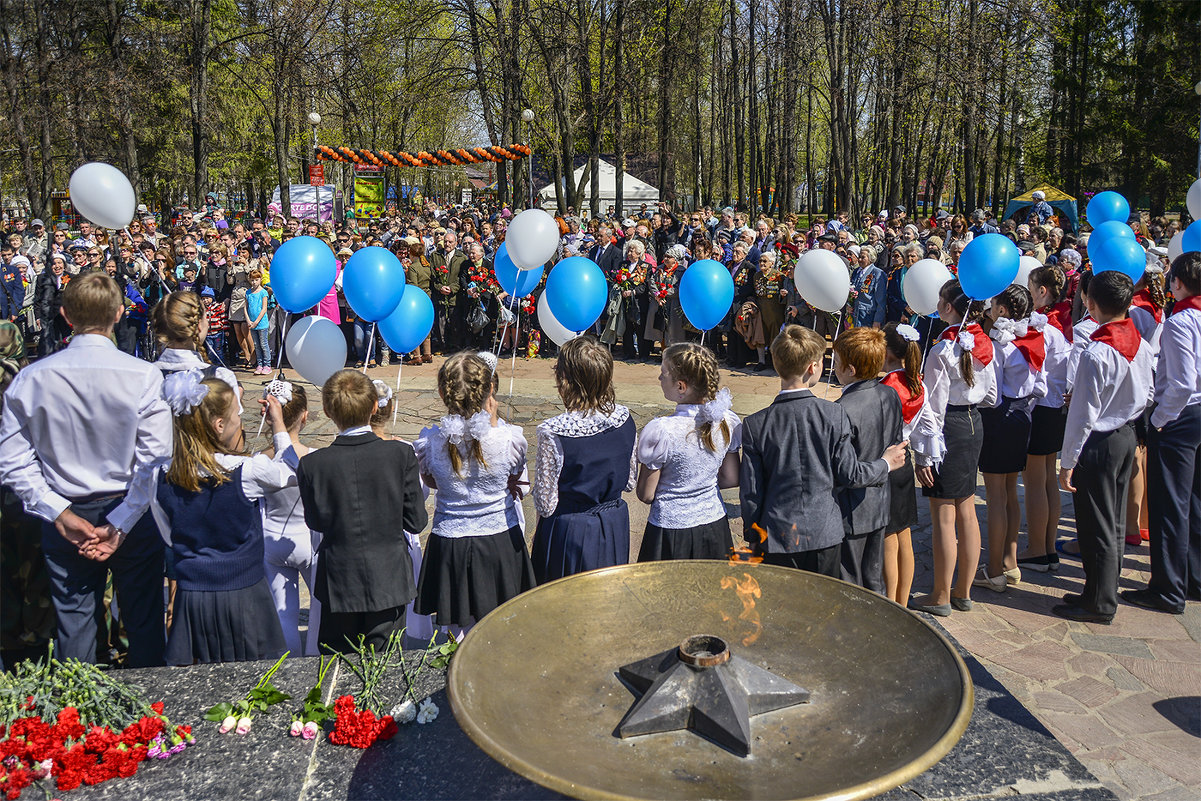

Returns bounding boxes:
[638,342,742,562]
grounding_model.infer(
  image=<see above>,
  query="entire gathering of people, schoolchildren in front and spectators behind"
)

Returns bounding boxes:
[0,198,1201,665]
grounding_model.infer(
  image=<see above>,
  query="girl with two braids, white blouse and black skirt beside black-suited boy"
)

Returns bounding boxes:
[413,353,534,638]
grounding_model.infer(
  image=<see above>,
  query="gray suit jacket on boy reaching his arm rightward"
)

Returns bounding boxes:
[739,390,889,554]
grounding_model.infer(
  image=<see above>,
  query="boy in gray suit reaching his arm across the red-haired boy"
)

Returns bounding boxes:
[739,325,904,579]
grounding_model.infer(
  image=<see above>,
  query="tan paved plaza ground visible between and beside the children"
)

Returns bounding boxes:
[239,359,1201,801]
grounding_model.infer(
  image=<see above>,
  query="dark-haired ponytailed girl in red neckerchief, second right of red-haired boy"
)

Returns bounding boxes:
[909,281,997,617]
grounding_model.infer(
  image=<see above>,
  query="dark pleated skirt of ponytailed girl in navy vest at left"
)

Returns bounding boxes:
[166,576,287,665]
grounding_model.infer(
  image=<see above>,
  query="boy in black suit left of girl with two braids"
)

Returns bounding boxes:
[297,370,429,651]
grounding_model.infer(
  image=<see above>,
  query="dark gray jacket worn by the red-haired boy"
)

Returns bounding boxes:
[838,378,904,537]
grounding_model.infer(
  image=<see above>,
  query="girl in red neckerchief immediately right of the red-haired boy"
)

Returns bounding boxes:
[880,323,926,606]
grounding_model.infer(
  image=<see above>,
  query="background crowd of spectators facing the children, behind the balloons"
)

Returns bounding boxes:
[0,192,1181,372]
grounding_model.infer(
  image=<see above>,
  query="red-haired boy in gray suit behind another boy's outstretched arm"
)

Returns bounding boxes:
[833,328,904,594]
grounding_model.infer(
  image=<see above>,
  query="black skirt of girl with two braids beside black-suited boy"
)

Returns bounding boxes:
[414,526,534,626]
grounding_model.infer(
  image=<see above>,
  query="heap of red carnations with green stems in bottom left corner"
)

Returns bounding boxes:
[0,644,193,799]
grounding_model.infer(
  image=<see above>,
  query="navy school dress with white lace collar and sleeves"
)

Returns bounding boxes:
[531,406,637,584]
